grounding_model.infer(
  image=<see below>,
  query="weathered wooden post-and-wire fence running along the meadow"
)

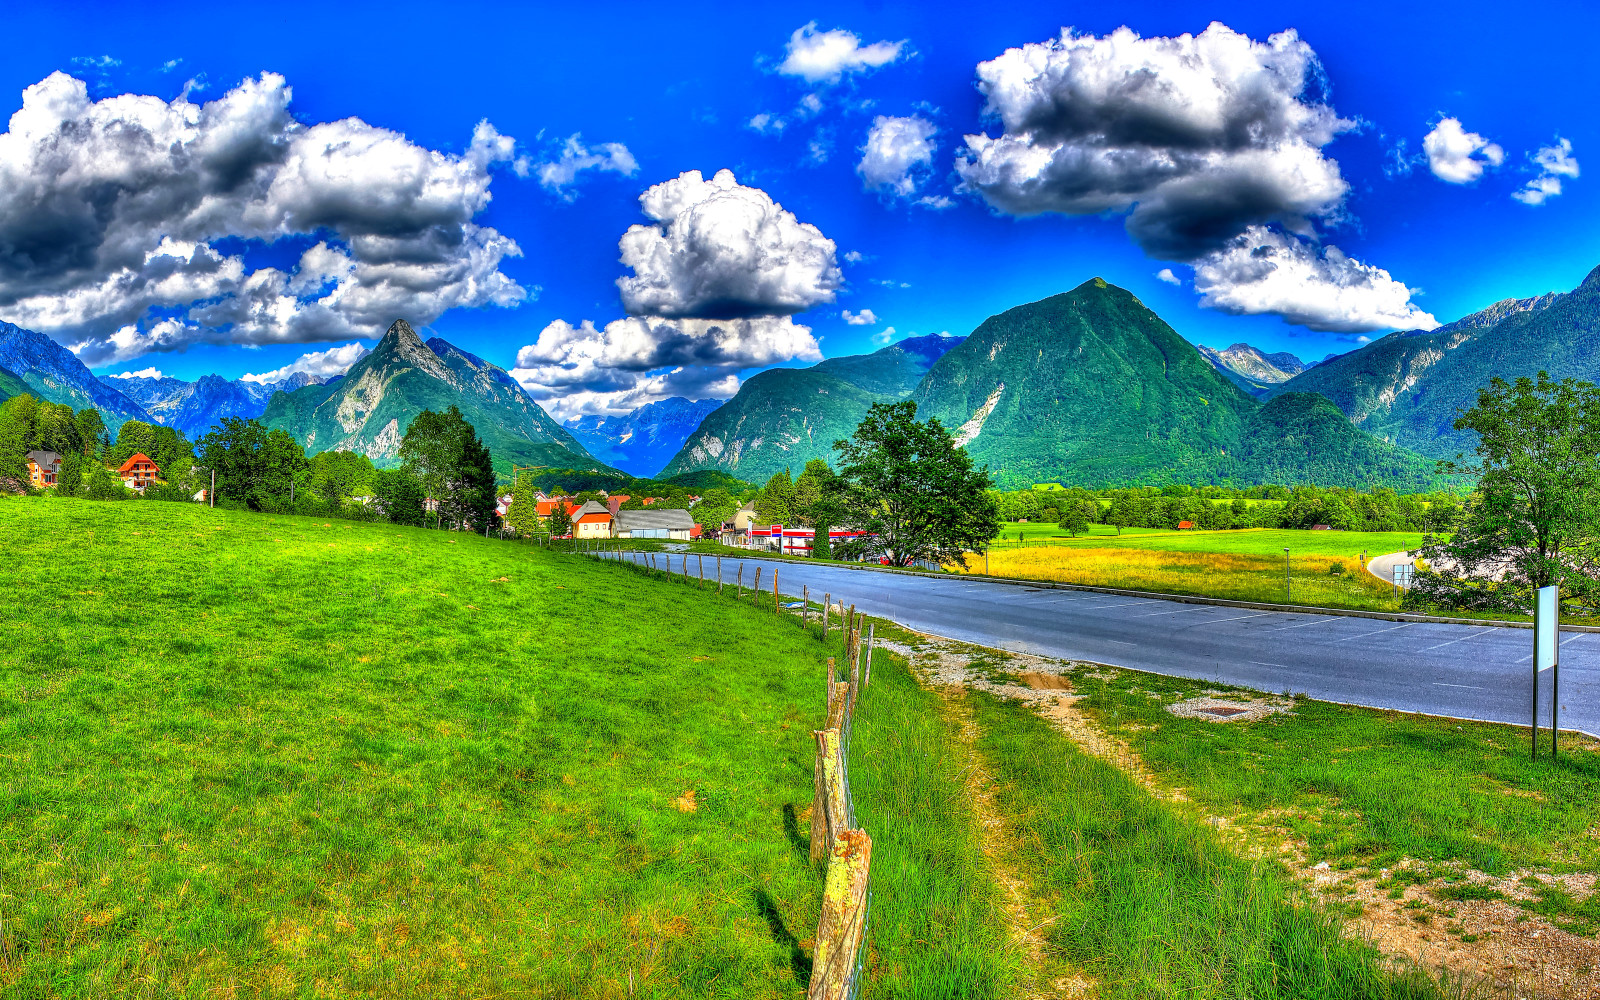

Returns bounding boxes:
[579,546,875,1000]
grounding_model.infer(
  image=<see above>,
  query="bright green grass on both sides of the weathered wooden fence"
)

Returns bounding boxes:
[0,498,1005,997]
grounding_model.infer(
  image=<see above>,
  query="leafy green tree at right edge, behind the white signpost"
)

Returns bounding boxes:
[1416,371,1600,608]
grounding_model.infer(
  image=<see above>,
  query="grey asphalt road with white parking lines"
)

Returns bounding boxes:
[611,555,1600,734]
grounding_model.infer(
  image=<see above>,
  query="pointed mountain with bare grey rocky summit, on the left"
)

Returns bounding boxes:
[261,320,610,475]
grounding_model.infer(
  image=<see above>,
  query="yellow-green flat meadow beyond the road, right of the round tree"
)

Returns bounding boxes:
[965,525,1422,611]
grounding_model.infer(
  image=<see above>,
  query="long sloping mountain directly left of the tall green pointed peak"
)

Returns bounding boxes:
[656,334,960,483]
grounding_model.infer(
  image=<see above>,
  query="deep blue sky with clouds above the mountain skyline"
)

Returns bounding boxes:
[0,3,1600,416]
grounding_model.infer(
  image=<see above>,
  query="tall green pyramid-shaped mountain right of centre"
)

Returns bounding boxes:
[912,278,1258,486]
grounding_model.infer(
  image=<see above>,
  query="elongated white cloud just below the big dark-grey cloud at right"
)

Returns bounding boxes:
[1194,227,1438,333]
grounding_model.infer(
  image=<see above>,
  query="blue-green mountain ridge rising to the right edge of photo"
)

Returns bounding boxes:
[1270,267,1600,458]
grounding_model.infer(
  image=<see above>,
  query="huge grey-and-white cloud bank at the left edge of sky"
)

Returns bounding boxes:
[0,72,526,365]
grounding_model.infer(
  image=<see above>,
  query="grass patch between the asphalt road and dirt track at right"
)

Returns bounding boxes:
[1072,669,1600,936]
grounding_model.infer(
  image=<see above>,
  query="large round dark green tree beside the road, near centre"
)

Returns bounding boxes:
[834,400,1000,566]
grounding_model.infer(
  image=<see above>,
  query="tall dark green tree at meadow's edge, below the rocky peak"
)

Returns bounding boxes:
[400,406,496,530]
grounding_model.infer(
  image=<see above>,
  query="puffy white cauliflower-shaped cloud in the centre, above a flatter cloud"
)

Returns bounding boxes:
[618,170,843,318]
